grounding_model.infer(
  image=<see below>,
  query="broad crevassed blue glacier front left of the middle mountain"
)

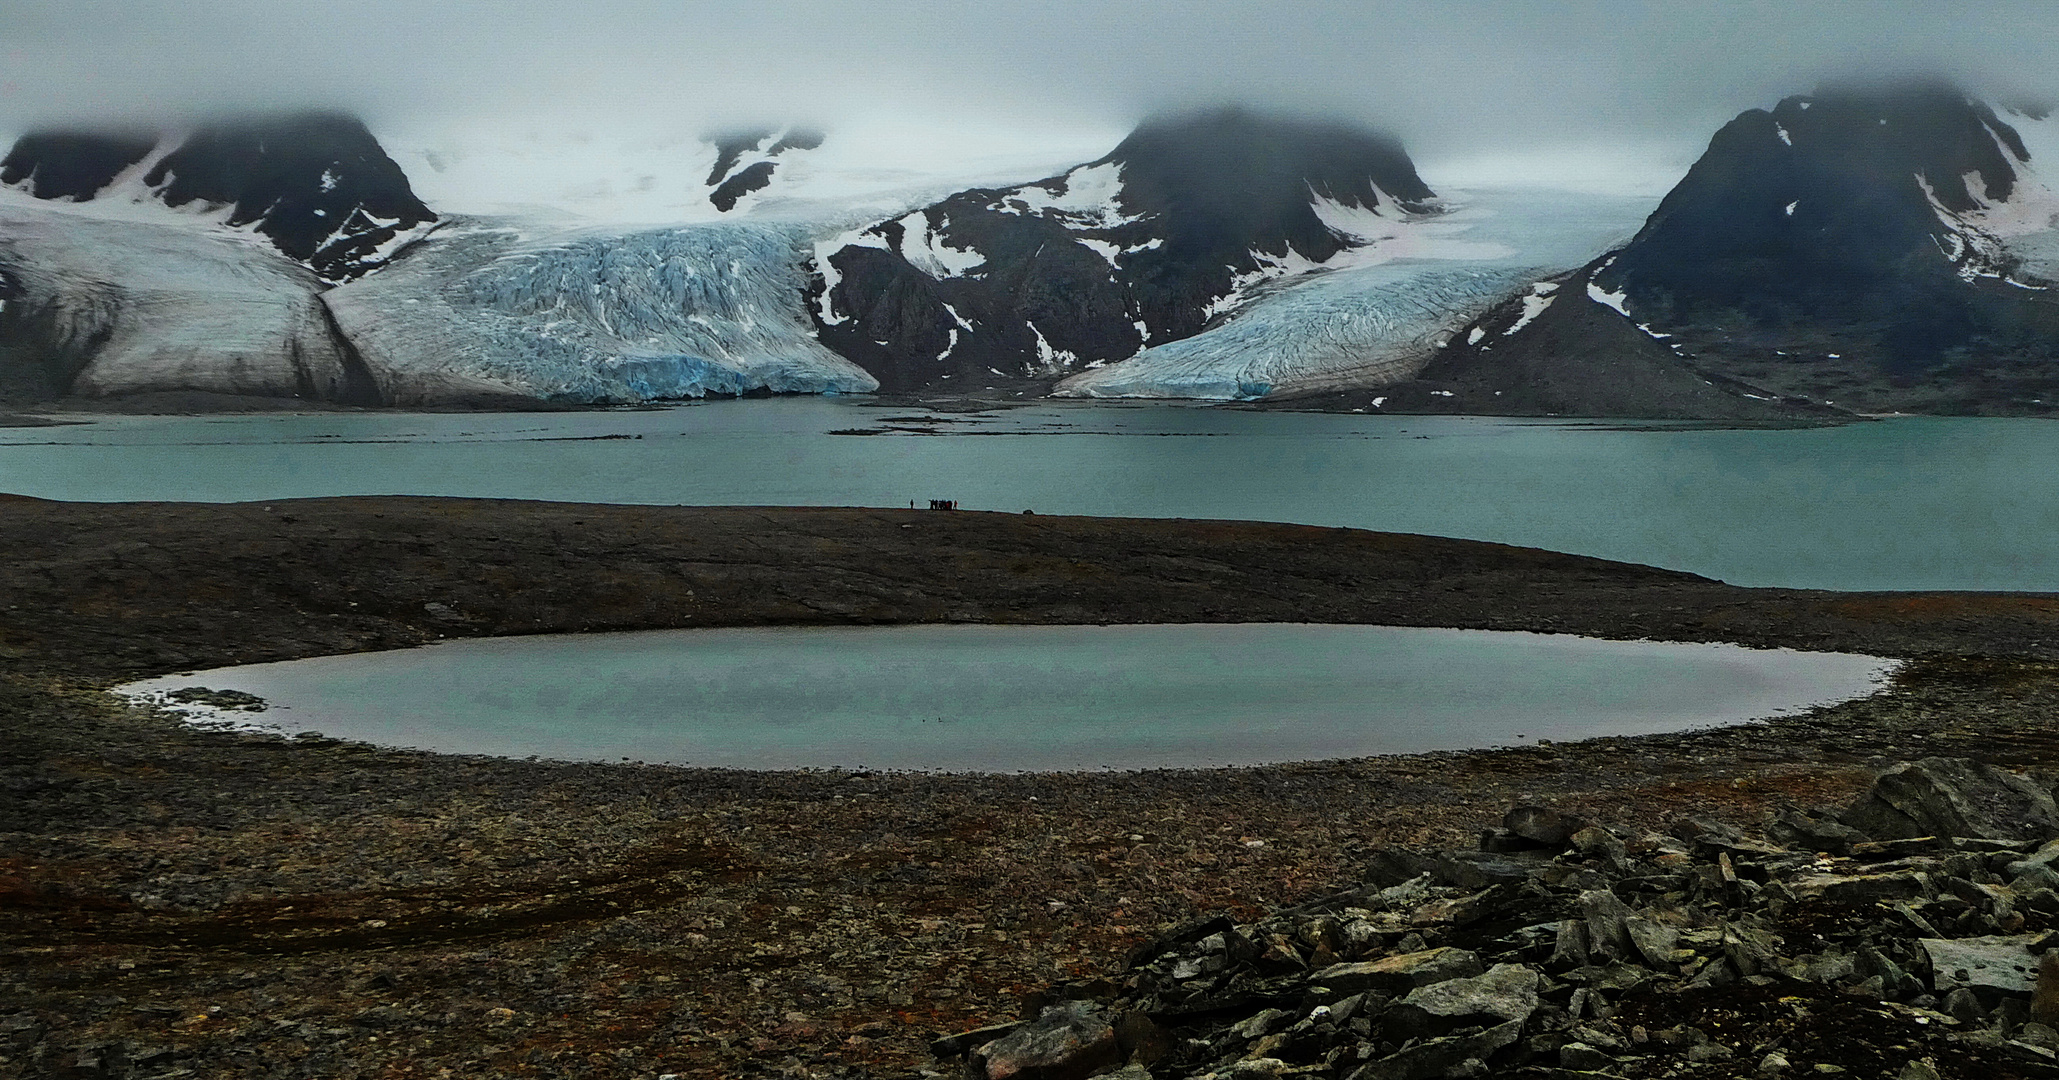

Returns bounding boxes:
[323,218,879,405]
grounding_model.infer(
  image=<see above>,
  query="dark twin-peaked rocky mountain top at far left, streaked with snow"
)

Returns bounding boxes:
[0,111,437,282]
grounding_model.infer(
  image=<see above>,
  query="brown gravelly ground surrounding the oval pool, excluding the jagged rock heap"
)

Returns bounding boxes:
[0,498,2059,1078]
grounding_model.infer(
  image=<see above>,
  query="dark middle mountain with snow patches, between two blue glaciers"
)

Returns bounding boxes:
[813,109,1435,391]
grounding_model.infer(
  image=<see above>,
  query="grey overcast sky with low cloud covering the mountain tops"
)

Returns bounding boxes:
[0,0,2059,188]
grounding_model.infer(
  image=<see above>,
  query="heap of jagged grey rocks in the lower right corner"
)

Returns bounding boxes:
[933,757,2059,1080]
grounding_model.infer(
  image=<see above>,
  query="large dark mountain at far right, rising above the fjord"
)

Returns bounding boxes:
[1433,82,2059,416]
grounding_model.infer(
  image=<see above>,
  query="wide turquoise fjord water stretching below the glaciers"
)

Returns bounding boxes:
[0,397,2059,590]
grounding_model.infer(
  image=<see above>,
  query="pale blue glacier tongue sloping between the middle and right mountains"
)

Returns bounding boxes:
[1054,187,1657,401]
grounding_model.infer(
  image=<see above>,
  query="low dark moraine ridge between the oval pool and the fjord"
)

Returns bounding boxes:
[0,496,2059,677]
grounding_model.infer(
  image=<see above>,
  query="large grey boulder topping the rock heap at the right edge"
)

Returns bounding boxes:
[1839,757,2059,839]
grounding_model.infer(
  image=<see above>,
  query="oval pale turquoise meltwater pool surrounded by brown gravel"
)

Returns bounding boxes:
[119,623,1892,771]
